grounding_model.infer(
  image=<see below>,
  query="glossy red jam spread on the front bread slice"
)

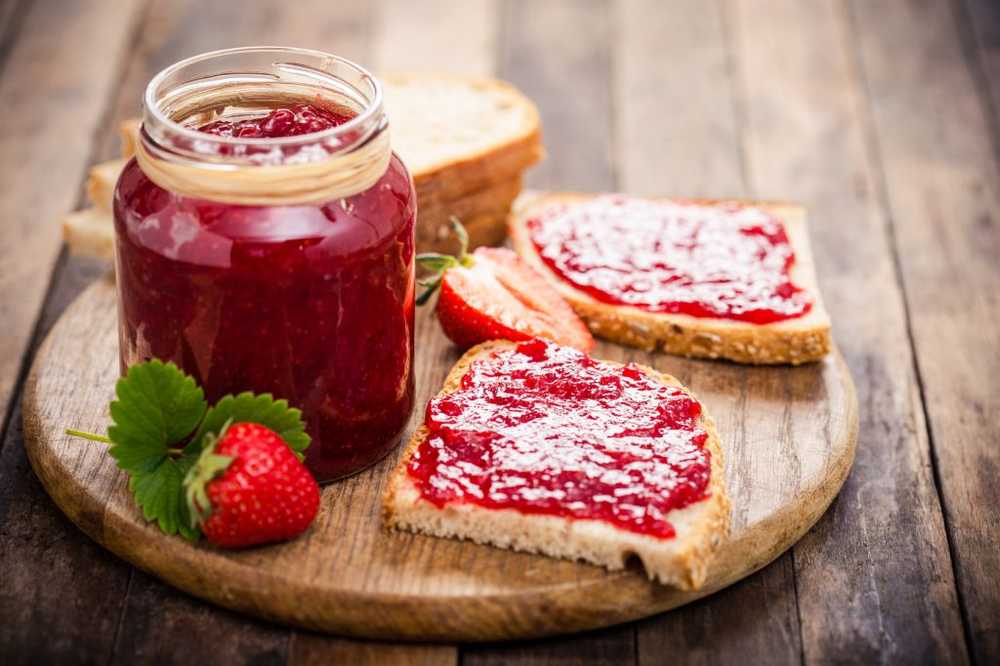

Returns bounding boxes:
[408,339,711,538]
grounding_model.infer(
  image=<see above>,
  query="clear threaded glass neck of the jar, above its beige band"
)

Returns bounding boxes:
[139,47,390,170]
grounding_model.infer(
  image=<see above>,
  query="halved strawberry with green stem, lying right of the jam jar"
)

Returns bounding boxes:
[417,219,594,352]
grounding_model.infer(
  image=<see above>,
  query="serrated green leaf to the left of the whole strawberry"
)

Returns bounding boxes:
[108,360,208,539]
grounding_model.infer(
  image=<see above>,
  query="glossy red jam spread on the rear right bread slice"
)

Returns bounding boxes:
[528,197,812,324]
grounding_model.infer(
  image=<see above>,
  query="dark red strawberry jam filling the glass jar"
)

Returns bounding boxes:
[115,105,416,481]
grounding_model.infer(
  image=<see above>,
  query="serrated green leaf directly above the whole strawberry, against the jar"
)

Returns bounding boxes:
[184,392,309,460]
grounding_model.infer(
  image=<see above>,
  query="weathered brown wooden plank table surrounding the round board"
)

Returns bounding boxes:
[0,0,1000,665]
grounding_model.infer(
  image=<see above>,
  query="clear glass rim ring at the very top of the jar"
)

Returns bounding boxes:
[143,46,383,148]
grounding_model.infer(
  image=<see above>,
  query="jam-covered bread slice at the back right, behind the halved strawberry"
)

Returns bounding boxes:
[508,193,831,365]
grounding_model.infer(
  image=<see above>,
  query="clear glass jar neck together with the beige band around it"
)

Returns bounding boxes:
[135,46,392,205]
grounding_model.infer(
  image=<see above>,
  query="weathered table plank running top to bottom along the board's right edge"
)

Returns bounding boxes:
[733,0,965,663]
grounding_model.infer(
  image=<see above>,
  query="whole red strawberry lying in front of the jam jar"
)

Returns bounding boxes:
[184,423,319,548]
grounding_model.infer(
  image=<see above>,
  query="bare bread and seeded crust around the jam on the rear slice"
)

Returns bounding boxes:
[508,193,832,365]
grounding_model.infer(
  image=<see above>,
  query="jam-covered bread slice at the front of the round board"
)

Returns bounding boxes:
[384,339,729,590]
